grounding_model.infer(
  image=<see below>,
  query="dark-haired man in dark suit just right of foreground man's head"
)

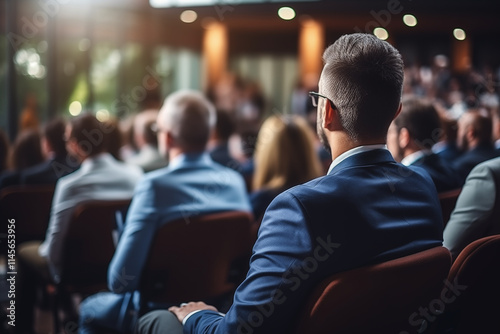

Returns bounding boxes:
[387,97,462,192]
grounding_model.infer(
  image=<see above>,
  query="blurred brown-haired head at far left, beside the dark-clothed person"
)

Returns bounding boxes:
[10,130,43,170]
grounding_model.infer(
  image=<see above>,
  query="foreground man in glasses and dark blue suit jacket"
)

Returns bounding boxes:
[137,34,442,334]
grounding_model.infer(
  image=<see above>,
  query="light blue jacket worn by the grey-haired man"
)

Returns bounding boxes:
[108,153,251,293]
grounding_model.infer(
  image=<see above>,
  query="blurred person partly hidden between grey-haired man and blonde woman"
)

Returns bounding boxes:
[208,110,241,172]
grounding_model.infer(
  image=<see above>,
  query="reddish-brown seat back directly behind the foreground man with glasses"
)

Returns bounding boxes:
[295,247,451,334]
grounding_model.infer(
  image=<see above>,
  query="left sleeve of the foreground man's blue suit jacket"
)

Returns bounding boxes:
[184,192,312,334]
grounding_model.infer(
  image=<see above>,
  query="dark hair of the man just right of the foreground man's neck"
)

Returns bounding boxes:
[394,97,442,149]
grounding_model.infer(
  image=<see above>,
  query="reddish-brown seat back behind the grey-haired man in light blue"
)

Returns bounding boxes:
[140,211,253,313]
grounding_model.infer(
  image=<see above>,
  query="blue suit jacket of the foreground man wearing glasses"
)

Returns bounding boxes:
[184,149,443,334]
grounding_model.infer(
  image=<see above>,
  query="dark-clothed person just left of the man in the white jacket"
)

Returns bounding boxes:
[21,118,79,185]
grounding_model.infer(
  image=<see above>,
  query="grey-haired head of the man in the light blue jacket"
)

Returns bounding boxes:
[158,90,217,152]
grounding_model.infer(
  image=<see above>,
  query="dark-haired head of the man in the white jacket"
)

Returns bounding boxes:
[70,113,106,157]
